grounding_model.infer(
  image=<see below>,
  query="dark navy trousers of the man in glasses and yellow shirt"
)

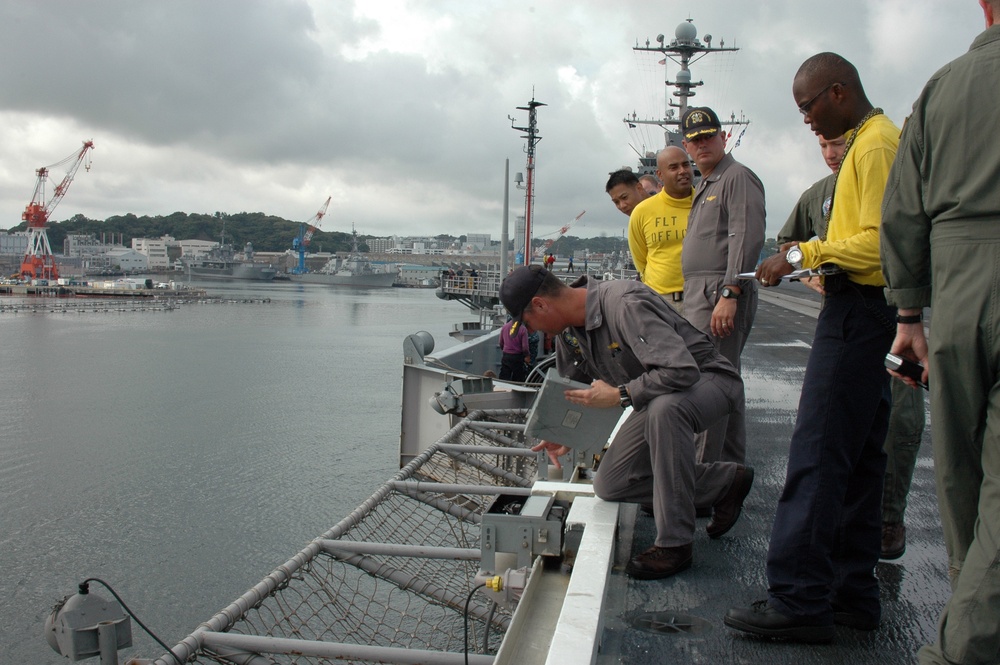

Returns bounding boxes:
[767,283,895,623]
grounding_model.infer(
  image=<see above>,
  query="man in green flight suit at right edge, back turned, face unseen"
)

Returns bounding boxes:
[881,0,1000,665]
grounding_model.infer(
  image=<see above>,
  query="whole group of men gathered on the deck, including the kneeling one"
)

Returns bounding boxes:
[501,0,1000,664]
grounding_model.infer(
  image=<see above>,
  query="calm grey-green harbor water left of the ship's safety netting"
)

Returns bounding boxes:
[0,282,473,664]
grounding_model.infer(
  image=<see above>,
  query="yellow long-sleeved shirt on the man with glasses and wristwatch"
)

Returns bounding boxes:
[799,114,899,286]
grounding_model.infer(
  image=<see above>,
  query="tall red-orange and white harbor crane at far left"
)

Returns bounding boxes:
[21,141,94,279]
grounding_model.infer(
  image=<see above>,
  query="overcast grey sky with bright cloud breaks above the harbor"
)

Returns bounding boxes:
[0,0,984,243]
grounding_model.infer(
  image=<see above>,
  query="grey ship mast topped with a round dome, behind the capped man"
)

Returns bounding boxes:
[622,19,750,173]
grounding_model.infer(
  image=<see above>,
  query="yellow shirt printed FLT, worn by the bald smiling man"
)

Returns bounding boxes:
[628,190,694,293]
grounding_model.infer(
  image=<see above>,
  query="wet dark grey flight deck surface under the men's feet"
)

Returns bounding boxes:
[598,287,951,665]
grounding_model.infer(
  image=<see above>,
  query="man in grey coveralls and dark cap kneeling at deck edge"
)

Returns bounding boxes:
[500,266,753,579]
